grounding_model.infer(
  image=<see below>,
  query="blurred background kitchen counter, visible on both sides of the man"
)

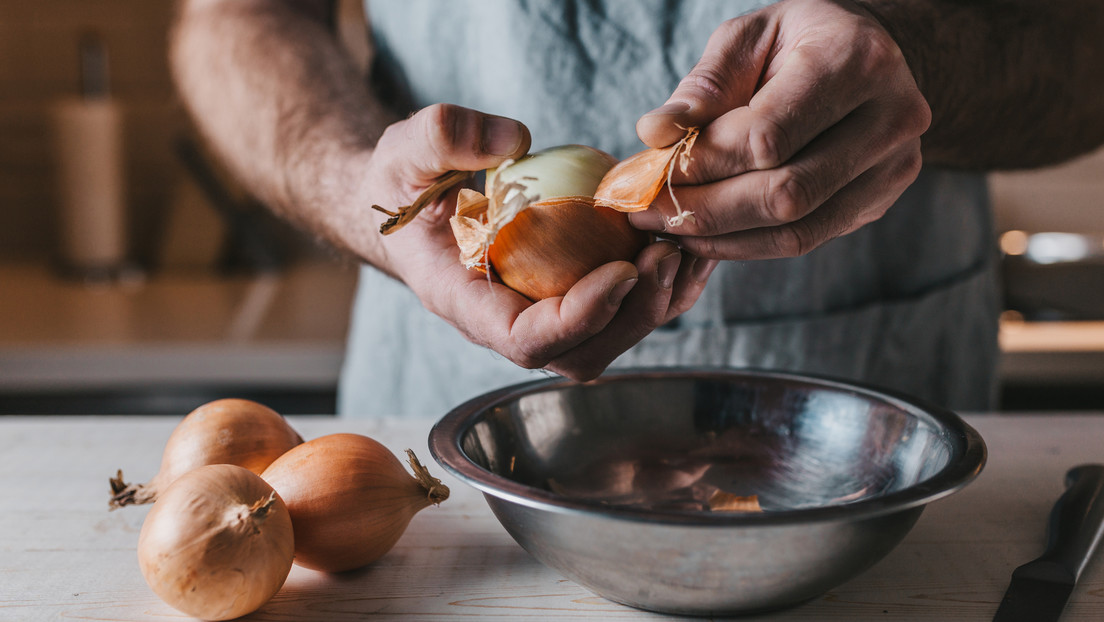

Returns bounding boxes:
[0,257,1104,413]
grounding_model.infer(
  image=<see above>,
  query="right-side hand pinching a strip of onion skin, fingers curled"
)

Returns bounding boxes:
[631,0,931,260]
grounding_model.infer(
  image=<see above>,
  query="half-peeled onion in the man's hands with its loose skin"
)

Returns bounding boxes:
[373,128,698,301]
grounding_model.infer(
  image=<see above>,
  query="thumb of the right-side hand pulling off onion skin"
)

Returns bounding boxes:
[636,14,774,147]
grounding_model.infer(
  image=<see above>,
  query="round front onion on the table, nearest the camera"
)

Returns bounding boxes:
[138,464,295,620]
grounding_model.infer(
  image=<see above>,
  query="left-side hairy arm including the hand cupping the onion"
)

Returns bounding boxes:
[170,0,715,380]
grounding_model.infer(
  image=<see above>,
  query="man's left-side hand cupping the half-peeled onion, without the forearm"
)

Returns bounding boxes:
[361,104,715,380]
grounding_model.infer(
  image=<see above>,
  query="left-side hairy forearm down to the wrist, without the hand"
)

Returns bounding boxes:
[170,0,395,266]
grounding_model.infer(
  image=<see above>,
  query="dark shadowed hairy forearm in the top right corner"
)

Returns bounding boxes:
[858,0,1104,169]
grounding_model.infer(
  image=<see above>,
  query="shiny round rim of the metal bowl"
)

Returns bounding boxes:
[428,367,987,527]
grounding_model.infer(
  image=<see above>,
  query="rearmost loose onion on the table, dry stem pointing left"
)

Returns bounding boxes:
[109,399,302,509]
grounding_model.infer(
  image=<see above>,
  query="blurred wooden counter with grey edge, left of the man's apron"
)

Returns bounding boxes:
[0,259,357,412]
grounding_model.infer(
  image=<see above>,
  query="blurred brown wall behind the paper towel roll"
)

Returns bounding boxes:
[0,0,187,261]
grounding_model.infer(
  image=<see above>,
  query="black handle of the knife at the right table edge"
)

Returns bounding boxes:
[1042,464,1104,581]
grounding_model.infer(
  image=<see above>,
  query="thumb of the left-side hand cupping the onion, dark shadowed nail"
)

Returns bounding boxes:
[403,104,532,179]
